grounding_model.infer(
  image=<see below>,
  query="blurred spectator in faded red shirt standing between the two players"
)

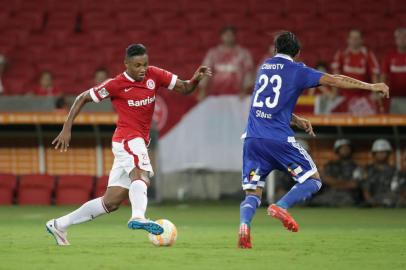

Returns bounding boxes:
[200,26,254,99]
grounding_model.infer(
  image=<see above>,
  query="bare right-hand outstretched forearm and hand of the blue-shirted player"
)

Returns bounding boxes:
[320,74,389,98]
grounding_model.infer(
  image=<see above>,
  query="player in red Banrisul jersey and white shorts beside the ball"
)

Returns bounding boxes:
[46,44,211,245]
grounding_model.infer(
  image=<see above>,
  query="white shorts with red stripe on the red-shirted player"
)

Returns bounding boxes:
[108,138,154,189]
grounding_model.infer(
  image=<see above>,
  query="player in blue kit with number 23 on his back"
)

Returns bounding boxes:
[238,32,389,248]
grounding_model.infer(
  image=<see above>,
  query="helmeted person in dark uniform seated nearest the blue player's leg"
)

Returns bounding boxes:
[312,139,362,207]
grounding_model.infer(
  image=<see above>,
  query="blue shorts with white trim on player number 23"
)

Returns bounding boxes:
[242,137,317,190]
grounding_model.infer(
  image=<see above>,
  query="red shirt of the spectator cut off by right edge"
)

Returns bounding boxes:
[382,51,406,97]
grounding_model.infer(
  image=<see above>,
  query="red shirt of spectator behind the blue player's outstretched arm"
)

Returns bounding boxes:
[331,47,379,97]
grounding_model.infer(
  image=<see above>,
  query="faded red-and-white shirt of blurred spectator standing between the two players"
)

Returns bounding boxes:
[203,45,254,95]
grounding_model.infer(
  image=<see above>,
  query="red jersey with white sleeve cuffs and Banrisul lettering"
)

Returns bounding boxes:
[90,66,178,144]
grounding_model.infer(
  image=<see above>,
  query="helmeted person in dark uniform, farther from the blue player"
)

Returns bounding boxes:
[362,139,397,207]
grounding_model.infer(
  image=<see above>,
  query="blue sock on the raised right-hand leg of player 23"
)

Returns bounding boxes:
[276,178,321,209]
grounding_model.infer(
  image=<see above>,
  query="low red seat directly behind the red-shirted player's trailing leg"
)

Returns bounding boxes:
[56,175,93,205]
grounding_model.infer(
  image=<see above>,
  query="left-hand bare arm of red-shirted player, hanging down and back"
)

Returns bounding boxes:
[52,90,92,152]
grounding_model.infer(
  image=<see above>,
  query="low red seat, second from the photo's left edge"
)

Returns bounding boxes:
[17,174,55,205]
